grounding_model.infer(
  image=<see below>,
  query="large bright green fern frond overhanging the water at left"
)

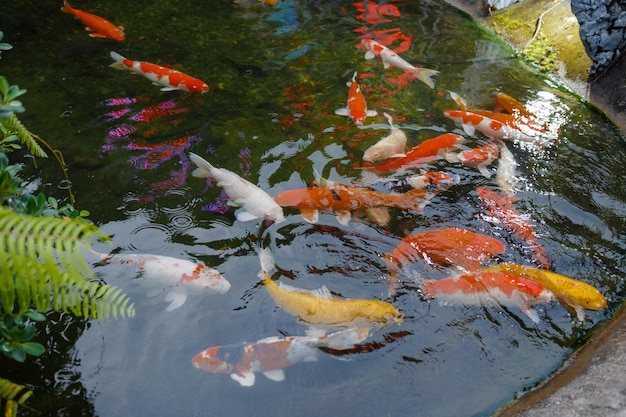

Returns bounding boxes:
[0,208,135,319]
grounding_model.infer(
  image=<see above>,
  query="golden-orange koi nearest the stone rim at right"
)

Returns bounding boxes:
[485,263,607,321]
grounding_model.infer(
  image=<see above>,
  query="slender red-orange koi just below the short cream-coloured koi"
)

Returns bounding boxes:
[368,133,465,172]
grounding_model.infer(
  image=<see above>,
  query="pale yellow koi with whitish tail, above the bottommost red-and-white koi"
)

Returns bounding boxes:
[263,276,404,328]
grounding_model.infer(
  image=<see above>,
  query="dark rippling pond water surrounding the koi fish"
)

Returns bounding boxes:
[0,0,626,417]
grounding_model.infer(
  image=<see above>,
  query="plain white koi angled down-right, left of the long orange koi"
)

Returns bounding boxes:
[189,153,285,223]
